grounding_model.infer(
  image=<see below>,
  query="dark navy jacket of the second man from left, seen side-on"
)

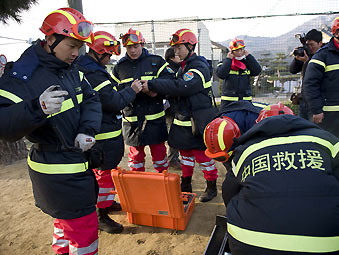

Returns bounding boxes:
[77,55,136,170]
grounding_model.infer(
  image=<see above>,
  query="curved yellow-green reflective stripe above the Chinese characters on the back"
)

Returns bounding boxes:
[233,135,339,176]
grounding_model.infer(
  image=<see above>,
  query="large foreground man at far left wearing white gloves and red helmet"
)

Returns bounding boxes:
[0,8,102,254]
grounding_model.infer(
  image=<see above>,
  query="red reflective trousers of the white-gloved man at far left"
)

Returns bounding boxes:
[52,212,98,255]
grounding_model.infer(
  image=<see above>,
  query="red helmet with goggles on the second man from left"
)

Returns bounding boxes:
[87,31,121,55]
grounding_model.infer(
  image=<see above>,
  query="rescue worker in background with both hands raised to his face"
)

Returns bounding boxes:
[217,38,261,109]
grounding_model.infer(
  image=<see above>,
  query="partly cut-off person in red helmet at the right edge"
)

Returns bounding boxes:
[303,17,339,137]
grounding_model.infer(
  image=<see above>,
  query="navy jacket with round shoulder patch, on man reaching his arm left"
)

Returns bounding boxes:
[148,54,218,150]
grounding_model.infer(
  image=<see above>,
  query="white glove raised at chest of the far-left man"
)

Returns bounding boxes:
[39,85,68,114]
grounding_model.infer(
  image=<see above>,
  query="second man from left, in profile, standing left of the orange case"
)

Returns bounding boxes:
[77,31,141,233]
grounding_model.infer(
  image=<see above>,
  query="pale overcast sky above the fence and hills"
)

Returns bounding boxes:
[0,0,339,61]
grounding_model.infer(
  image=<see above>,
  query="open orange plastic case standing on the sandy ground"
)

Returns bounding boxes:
[111,169,196,230]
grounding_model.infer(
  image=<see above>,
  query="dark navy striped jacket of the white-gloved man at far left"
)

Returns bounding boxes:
[0,41,101,219]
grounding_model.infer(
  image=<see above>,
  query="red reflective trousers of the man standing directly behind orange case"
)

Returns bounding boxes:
[128,143,168,173]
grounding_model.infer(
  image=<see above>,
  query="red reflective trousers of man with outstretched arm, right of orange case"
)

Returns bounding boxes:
[179,150,218,181]
